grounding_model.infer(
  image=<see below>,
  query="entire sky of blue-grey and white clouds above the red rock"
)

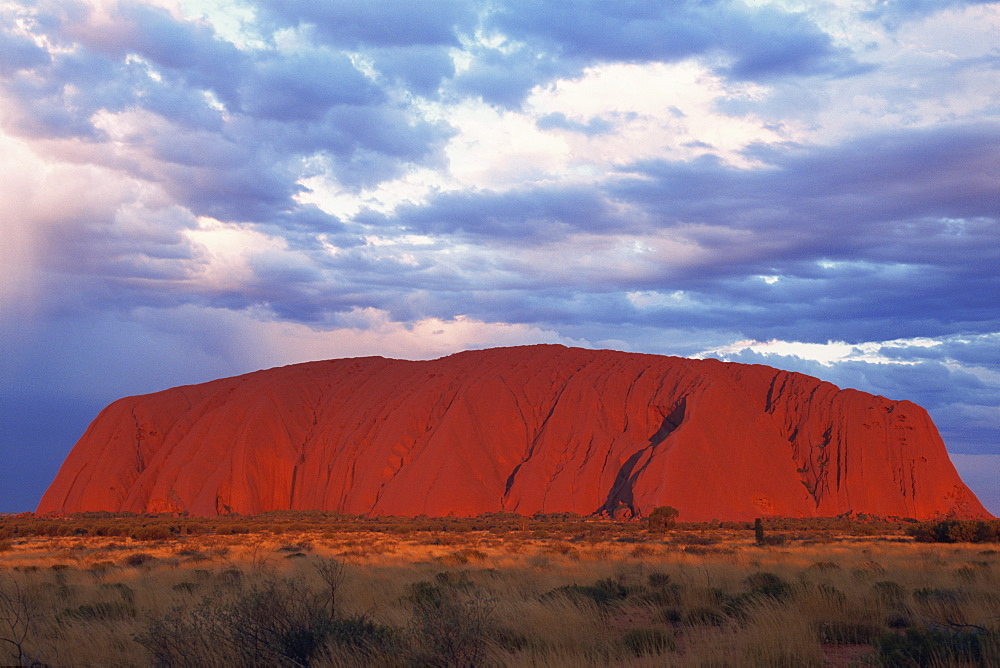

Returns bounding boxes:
[0,0,1000,513]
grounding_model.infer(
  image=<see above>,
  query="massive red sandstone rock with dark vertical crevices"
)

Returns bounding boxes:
[38,346,989,521]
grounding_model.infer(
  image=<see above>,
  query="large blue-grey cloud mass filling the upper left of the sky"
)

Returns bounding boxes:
[0,1,454,253]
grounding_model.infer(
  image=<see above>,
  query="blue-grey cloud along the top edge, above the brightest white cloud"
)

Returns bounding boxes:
[456,0,866,107]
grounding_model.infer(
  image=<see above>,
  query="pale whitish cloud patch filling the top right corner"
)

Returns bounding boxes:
[776,3,1000,143]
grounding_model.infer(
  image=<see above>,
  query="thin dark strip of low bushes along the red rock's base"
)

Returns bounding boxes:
[0,510,936,542]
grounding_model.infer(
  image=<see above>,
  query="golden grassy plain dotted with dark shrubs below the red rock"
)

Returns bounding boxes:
[0,512,1000,666]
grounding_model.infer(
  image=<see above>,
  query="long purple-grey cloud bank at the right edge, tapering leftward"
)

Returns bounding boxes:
[614,123,1000,235]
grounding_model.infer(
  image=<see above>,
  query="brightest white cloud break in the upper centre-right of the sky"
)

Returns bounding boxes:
[300,60,792,217]
